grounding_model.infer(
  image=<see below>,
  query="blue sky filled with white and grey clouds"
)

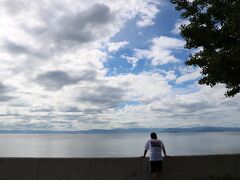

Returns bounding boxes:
[0,0,240,131]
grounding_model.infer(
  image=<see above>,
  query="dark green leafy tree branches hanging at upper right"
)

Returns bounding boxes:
[171,0,240,96]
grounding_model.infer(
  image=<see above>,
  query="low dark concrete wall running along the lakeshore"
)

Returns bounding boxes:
[0,155,240,180]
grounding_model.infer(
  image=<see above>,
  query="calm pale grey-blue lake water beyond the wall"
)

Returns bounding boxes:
[0,132,240,157]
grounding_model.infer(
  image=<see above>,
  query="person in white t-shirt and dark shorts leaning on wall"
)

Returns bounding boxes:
[143,132,167,180]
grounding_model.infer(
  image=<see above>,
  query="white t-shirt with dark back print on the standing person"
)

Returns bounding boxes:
[145,139,165,161]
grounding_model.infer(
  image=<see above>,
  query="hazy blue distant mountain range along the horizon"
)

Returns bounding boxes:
[0,126,240,134]
